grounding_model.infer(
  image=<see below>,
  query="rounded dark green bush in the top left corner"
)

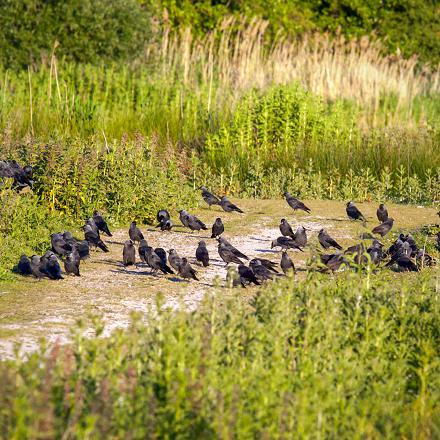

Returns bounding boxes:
[0,0,151,68]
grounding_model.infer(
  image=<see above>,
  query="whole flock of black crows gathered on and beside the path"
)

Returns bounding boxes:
[5,161,440,287]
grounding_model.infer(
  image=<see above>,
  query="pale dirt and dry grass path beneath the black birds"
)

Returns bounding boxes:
[0,200,435,358]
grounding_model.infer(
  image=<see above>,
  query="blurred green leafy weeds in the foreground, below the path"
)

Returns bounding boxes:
[0,271,440,438]
